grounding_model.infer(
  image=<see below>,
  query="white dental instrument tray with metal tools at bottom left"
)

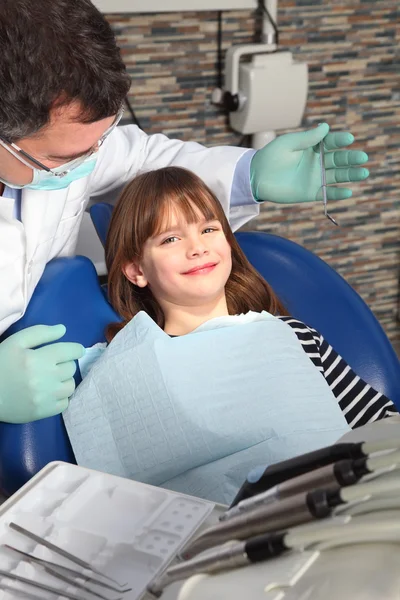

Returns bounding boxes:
[0,462,215,600]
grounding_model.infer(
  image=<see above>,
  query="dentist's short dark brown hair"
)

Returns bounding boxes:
[0,0,130,142]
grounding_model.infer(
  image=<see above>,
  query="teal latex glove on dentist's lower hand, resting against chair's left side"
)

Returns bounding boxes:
[0,325,85,423]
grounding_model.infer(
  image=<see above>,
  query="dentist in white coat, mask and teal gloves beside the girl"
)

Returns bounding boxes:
[0,0,368,423]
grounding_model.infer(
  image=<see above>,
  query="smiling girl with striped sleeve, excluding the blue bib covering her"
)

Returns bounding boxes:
[106,167,397,428]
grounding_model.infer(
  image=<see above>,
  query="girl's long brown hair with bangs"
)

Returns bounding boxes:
[106,167,286,341]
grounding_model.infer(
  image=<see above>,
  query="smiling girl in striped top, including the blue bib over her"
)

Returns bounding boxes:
[64,167,396,503]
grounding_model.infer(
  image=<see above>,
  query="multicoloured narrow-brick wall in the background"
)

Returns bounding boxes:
[108,0,400,340]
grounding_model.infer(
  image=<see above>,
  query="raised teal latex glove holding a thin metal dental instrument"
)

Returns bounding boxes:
[250,123,369,204]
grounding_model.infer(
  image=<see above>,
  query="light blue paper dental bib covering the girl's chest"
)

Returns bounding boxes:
[64,312,349,503]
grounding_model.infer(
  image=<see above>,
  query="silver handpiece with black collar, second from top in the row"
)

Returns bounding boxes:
[219,451,400,521]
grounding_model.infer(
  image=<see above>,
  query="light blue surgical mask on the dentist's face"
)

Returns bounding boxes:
[0,154,97,190]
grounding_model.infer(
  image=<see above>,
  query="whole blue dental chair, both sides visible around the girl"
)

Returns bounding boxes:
[0,204,400,495]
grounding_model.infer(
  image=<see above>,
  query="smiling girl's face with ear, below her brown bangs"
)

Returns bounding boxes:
[125,208,232,311]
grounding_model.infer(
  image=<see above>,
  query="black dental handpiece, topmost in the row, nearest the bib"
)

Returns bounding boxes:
[231,438,400,508]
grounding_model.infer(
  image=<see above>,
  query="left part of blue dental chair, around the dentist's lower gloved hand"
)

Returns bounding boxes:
[0,256,119,496]
